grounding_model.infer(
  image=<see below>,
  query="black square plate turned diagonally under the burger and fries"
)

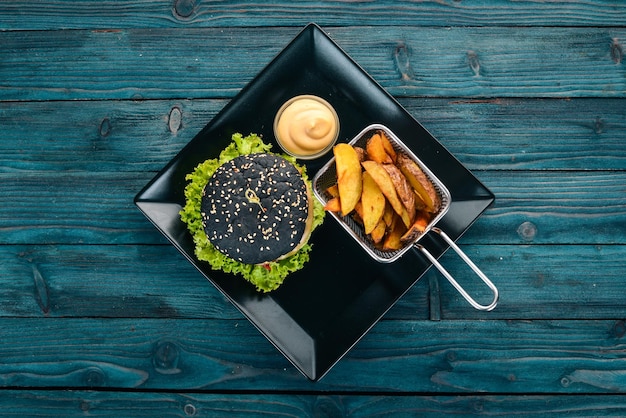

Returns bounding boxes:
[135,24,494,380]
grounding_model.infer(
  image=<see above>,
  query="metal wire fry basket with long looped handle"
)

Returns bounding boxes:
[313,124,498,311]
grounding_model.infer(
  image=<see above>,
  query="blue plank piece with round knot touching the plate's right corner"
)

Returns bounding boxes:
[478,171,626,245]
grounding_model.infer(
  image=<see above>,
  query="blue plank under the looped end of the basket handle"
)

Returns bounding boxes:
[420,242,626,320]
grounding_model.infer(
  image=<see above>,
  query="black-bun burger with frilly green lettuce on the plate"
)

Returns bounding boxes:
[181,134,324,292]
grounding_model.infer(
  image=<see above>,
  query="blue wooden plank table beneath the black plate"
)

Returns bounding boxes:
[0,0,626,417]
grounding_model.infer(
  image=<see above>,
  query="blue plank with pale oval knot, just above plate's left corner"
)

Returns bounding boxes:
[0,99,227,173]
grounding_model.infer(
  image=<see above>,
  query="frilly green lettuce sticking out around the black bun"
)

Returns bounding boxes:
[180,133,325,292]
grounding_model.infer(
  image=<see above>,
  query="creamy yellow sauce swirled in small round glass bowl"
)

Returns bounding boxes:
[274,96,339,157]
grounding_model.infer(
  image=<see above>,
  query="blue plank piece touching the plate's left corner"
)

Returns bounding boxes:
[0,172,158,245]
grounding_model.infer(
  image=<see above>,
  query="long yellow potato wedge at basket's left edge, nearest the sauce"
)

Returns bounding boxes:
[333,143,363,216]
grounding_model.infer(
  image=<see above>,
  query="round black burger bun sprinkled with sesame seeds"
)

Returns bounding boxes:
[201,153,313,264]
